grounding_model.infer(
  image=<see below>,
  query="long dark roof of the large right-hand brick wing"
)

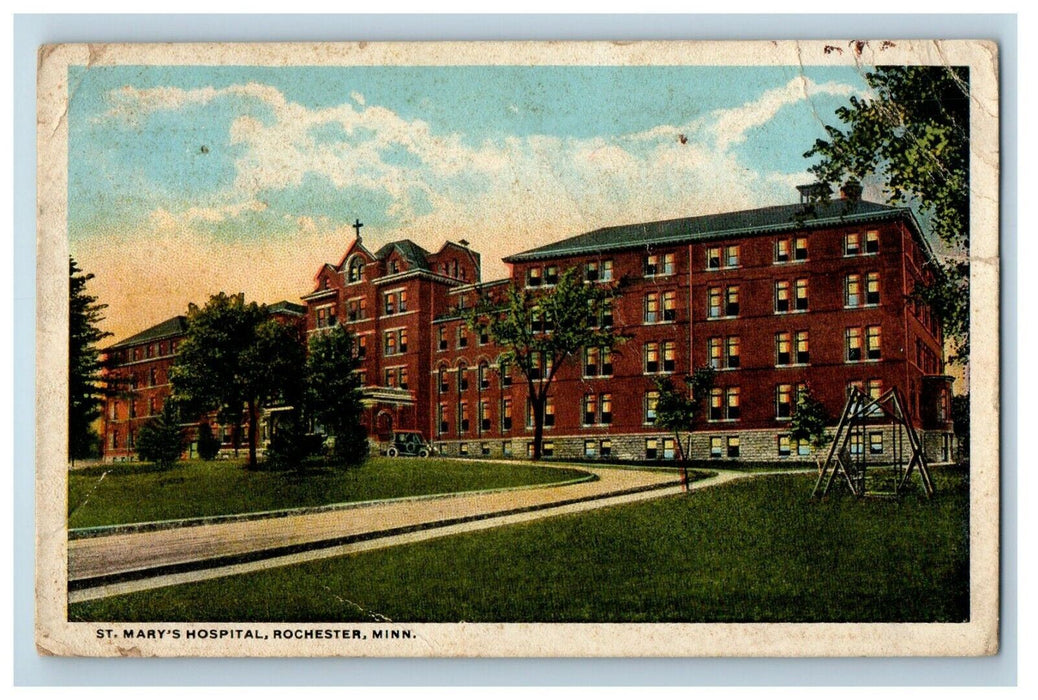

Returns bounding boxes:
[504,199,919,263]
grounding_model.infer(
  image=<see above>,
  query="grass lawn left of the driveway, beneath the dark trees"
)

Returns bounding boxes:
[69,457,586,528]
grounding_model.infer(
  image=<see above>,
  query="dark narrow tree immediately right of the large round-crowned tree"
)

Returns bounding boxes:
[306,326,367,464]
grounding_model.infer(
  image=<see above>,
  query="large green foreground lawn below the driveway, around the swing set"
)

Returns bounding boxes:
[69,470,968,622]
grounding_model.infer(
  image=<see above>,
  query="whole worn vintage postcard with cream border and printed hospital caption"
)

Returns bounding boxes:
[35,38,1000,656]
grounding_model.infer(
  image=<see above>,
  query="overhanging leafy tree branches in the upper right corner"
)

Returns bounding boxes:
[804,65,969,361]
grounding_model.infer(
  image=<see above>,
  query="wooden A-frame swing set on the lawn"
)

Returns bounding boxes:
[812,386,935,500]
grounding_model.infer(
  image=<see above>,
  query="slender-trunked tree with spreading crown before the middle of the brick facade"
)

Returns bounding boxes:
[465,268,626,460]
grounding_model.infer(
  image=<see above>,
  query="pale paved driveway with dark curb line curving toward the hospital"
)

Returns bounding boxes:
[69,468,784,602]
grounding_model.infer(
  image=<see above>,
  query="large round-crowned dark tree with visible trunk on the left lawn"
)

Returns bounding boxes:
[169,292,304,469]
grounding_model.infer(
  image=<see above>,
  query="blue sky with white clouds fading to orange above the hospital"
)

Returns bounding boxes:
[69,65,878,340]
